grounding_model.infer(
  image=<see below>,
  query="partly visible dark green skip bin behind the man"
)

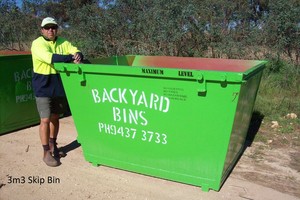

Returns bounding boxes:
[0,52,40,135]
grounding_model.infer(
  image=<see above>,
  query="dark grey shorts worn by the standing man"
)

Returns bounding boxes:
[35,97,68,118]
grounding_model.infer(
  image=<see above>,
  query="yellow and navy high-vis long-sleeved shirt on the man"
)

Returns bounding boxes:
[31,36,80,97]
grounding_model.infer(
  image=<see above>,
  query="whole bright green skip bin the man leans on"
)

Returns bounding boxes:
[55,56,266,191]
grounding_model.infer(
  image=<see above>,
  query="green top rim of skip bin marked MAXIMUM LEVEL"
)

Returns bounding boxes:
[54,63,264,83]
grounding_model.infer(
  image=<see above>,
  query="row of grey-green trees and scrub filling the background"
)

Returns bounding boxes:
[0,0,300,65]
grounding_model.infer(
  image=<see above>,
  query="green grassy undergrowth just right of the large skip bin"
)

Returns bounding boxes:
[255,60,300,120]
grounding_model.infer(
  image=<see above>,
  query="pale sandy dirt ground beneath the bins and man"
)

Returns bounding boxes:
[0,116,300,200]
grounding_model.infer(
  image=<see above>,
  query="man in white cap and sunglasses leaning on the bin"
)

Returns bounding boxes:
[31,17,83,167]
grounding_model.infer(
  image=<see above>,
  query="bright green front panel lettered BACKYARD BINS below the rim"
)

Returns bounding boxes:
[61,66,239,190]
